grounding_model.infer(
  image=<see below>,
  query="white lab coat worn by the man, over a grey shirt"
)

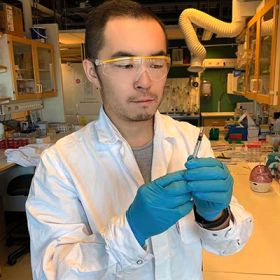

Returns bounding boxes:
[26,109,252,280]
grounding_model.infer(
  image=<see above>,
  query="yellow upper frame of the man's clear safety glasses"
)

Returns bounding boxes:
[90,55,171,81]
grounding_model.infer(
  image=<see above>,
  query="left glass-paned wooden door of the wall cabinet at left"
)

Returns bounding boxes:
[9,40,37,99]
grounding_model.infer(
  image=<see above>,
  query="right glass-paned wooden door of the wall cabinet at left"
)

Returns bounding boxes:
[36,45,56,97]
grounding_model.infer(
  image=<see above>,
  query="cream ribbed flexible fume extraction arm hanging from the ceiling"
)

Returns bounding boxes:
[179,0,260,72]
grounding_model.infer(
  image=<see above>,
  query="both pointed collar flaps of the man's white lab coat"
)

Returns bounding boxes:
[96,107,176,144]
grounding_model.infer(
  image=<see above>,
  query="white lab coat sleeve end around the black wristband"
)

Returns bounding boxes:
[197,197,253,255]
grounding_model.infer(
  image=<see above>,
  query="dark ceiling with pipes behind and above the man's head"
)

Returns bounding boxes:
[33,0,232,30]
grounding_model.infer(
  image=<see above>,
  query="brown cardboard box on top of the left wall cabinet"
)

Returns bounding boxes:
[0,3,24,36]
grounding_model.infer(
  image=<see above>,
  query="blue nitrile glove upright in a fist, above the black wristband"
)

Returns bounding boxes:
[185,157,233,221]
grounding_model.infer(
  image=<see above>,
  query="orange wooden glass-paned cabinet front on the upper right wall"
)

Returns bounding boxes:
[245,0,278,105]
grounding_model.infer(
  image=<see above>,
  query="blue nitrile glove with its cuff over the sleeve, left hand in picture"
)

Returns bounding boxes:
[126,170,193,246]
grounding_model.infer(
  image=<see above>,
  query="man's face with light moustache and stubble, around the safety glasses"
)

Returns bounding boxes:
[96,17,166,123]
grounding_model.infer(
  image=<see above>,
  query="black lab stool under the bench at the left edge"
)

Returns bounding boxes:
[6,174,33,265]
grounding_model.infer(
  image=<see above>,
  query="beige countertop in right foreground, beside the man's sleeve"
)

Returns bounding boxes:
[203,162,280,280]
